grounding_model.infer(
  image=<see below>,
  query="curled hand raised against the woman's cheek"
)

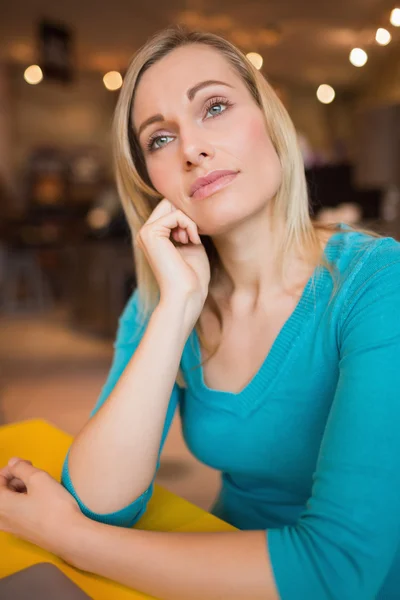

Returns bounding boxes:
[136,198,210,320]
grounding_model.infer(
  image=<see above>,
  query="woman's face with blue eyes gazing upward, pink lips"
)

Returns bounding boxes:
[132,44,281,235]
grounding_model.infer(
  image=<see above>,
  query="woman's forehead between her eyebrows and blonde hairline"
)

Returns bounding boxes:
[132,44,241,121]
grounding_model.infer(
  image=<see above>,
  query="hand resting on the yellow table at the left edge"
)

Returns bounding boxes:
[0,458,85,556]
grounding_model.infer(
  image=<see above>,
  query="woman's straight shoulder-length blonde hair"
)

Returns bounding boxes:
[113,25,378,385]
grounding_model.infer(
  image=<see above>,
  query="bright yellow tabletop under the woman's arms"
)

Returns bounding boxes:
[0,420,235,600]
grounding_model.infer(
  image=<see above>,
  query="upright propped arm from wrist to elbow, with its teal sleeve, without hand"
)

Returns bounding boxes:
[63,292,189,525]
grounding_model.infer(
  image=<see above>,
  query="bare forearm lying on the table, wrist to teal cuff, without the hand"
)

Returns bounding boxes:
[63,519,280,600]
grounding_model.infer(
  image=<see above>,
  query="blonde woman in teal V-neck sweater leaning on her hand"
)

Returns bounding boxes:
[0,28,400,600]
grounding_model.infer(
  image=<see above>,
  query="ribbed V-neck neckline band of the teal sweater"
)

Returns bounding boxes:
[185,224,343,416]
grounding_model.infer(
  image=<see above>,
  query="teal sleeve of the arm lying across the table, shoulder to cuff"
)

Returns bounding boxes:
[267,245,400,600]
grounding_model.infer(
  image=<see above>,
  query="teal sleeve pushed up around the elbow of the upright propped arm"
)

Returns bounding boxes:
[61,290,182,527]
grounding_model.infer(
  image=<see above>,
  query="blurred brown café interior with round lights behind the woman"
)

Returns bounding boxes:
[0,0,400,509]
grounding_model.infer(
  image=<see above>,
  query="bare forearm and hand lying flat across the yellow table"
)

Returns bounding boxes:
[0,458,278,600]
